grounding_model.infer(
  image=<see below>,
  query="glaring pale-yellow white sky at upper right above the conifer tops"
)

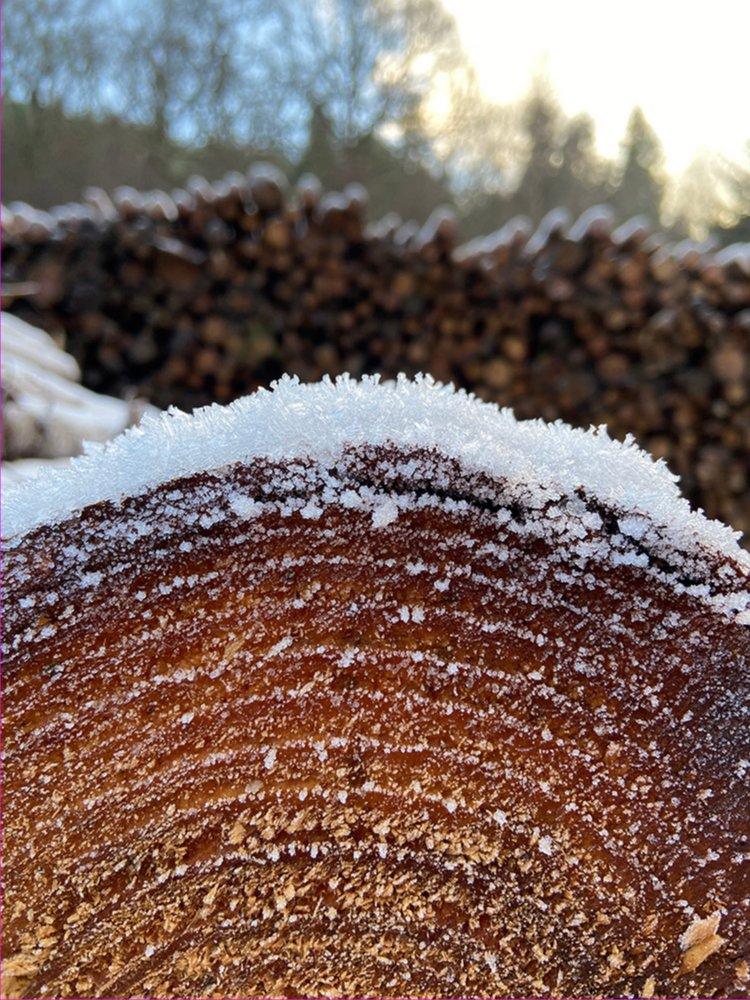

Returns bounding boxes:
[443,0,750,174]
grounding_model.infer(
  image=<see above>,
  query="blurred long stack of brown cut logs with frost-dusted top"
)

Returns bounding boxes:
[4,166,750,531]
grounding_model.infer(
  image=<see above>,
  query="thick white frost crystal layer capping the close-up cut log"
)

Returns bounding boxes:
[2,375,750,567]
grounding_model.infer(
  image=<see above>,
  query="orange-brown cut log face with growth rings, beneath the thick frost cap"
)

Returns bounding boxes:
[4,436,750,997]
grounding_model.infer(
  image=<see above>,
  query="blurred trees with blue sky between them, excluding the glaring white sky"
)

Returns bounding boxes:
[4,0,750,242]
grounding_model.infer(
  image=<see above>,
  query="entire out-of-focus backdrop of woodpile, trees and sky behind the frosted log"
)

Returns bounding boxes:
[2,0,750,531]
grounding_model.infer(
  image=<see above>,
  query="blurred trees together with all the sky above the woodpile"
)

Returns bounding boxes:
[4,0,750,238]
